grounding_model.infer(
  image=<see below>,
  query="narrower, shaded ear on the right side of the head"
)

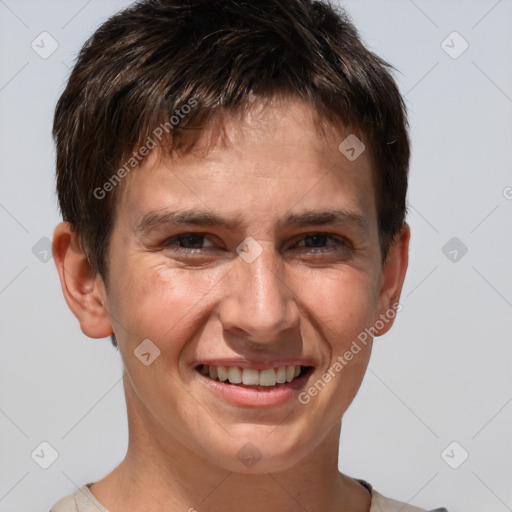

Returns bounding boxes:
[375,222,411,336]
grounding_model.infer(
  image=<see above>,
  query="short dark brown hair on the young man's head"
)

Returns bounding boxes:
[53,0,410,348]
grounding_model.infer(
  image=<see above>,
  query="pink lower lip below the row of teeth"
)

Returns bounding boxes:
[194,369,313,407]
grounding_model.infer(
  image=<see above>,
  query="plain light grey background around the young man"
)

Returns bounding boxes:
[0,0,512,512]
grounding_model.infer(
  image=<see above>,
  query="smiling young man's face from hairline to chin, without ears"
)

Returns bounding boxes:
[97,100,404,472]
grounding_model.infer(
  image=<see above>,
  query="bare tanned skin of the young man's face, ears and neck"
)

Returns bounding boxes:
[54,99,410,512]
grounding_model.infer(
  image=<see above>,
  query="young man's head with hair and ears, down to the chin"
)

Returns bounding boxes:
[53,0,409,470]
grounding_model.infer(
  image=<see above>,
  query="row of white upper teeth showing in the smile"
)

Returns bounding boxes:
[200,365,301,386]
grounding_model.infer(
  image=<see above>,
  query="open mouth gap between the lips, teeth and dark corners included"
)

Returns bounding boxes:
[195,364,314,390]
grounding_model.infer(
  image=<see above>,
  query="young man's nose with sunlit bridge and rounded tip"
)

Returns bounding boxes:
[219,241,300,344]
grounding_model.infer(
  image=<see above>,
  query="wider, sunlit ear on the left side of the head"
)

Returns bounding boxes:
[52,222,114,338]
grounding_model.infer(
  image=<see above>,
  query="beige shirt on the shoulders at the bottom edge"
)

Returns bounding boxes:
[50,480,448,512]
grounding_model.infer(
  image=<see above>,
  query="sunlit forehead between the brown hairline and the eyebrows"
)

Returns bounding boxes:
[116,96,376,236]
